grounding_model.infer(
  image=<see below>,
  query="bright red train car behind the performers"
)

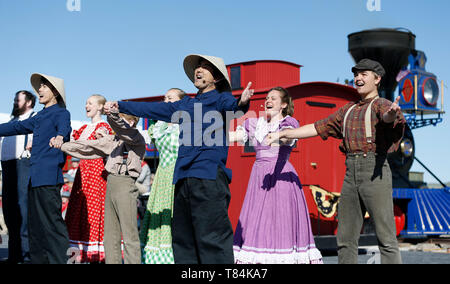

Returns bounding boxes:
[128,60,359,235]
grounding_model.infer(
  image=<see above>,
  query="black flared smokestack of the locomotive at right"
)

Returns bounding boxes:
[348,29,416,101]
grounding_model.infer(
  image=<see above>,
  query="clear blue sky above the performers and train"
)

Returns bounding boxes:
[0,0,450,182]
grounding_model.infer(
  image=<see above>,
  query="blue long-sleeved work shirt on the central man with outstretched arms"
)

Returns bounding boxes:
[119,90,249,184]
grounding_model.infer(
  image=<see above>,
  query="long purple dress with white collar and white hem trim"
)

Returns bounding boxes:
[233,116,322,264]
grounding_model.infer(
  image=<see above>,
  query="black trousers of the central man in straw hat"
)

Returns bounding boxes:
[172,168,234,264]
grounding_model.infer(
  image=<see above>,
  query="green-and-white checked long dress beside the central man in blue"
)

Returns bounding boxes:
[140,121,180,264]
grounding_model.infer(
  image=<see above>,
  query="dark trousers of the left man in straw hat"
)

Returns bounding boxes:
[28,185,69,264]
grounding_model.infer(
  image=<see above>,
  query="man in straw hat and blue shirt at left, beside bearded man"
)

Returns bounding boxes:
[0,73,72,263]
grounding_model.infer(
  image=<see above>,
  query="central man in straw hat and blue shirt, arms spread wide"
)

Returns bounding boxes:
[106,54,253,264]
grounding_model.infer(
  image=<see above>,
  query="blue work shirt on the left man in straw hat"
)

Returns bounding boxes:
[0,104,72,187]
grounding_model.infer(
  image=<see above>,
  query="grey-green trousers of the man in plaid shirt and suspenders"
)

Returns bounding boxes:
[337,153,401,263]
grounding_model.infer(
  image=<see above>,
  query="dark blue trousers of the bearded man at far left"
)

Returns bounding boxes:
[2,159,30,263]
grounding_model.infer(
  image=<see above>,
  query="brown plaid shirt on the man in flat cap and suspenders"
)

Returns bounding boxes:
[314,98,406,155]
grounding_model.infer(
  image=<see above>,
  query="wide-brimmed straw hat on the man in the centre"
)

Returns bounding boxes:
[183,54,231,90]
